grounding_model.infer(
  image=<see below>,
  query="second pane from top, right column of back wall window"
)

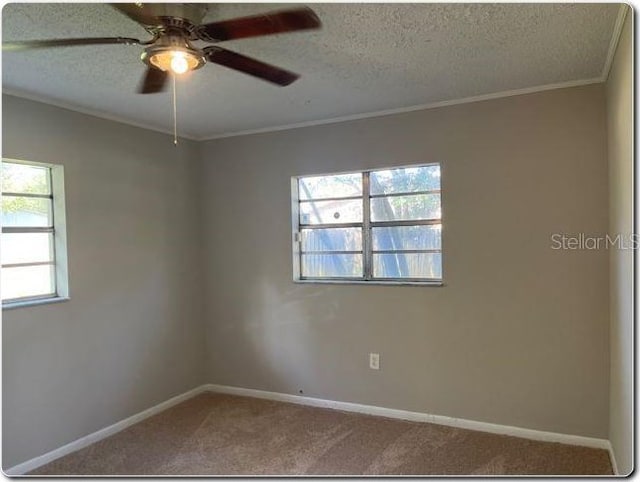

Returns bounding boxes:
[371,193,440,222]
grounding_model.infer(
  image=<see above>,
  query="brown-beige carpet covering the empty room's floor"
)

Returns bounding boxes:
[30,393,611,475]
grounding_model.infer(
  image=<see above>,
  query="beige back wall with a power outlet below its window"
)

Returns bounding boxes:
[201,85,609,438]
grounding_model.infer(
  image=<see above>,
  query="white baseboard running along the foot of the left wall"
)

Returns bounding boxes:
[3,385,208,476]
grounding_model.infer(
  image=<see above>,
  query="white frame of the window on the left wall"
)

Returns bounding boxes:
[0,158,69,310]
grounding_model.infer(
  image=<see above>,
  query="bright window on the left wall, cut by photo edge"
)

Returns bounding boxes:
[0,160,68,306]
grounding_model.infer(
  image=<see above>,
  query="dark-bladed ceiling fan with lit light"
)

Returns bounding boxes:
[2,3,321,94]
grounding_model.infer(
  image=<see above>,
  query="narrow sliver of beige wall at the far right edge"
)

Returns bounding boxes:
[606,12,633,474]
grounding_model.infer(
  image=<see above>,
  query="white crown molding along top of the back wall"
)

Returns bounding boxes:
[196,77,602,141]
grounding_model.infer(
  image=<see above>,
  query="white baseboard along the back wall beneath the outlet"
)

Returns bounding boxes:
[206,384,611,450]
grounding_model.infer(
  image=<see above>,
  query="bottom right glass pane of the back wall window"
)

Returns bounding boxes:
[373,253,442,279]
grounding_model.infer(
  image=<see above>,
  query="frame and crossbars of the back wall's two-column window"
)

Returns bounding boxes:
[291,162,444,286]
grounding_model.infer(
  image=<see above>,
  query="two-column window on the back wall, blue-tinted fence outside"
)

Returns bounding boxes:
[292,164,442,284]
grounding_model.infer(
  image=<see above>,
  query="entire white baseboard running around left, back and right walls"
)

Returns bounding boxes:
[3,384,618,476]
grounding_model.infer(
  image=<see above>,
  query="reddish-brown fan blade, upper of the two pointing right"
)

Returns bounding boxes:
[195,7,321,42]
